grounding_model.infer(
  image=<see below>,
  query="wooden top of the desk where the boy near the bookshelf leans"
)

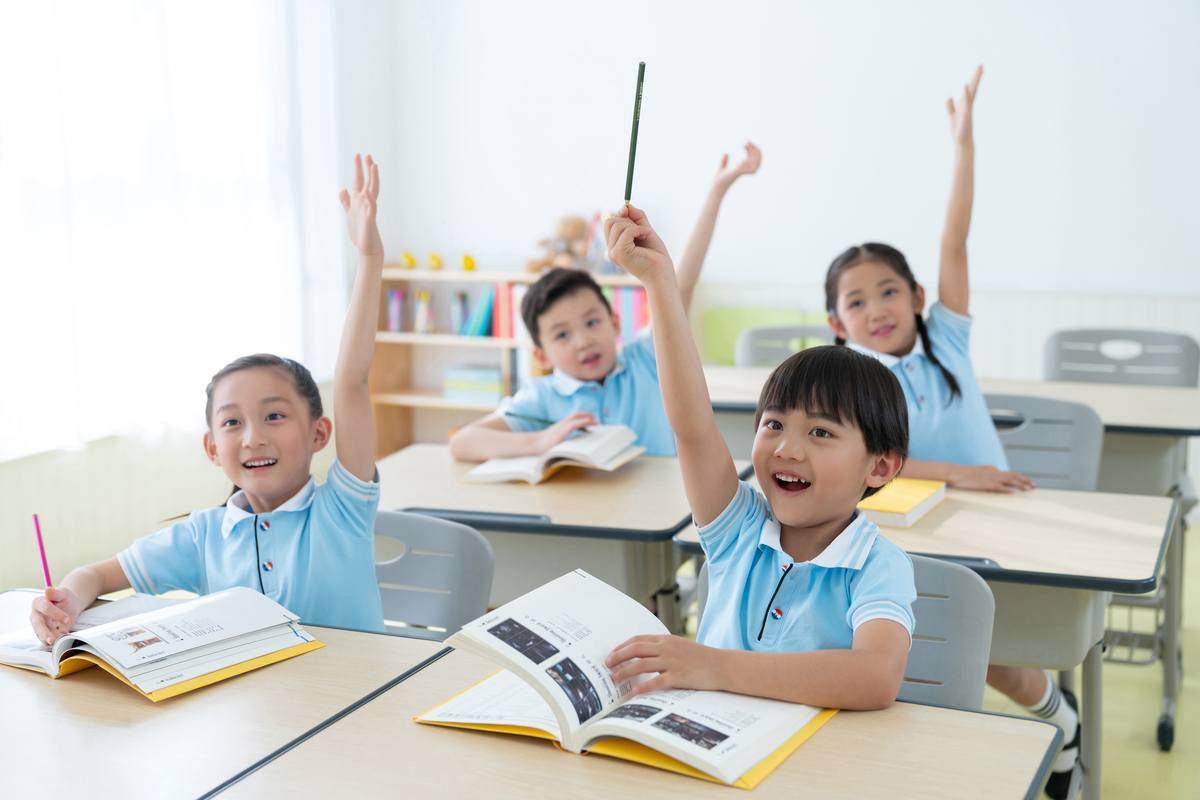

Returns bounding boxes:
[378,445,749,541]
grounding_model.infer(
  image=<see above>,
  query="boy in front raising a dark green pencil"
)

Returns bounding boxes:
[606,206,916,709]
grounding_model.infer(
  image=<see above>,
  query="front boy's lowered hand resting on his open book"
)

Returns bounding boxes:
[604,636,721,694]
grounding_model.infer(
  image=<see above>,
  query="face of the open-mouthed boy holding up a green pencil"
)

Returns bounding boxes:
[751,409,900,528]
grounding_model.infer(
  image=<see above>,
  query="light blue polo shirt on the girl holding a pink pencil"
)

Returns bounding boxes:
[116,461,385,631]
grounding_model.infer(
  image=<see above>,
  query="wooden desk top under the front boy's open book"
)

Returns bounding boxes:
[221,651,1058,800]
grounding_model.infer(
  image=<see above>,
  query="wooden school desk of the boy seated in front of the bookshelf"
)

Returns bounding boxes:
[378,445,749,630]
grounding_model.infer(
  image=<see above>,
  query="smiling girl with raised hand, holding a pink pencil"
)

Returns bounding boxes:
[30,156,384,644]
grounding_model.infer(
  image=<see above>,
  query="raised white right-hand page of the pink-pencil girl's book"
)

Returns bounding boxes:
[70,587,299,670]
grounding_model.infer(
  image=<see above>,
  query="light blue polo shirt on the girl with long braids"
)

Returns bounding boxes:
[850,302,1008,470]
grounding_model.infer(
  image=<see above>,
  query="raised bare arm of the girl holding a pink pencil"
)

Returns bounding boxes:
[334,156,383,481]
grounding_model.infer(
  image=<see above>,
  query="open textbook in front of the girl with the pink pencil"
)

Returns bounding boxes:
[0,587,324,702]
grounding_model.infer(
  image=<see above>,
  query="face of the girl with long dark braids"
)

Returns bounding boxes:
[829,261,925,355]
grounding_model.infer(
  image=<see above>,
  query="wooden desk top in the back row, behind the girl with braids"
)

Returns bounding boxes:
[704,366,1200,437]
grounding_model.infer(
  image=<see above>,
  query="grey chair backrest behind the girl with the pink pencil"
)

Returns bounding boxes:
[374,511,494,642]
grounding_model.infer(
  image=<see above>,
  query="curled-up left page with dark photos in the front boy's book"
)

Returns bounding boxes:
[446,570,668,752]
